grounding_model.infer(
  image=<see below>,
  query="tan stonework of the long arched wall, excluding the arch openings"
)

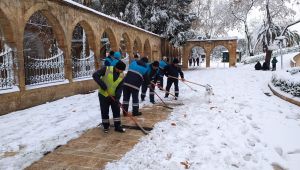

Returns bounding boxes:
[0,0,162,115]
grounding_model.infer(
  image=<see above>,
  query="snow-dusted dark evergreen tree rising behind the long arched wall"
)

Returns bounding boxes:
[73,0,195,46]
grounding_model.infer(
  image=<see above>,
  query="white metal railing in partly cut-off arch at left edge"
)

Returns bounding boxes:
[0,49,15,90]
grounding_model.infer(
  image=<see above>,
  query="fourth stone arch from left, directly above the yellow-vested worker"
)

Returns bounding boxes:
[100,28,119,59]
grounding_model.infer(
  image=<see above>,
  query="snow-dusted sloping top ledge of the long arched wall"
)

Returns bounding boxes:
[63,0,161,38]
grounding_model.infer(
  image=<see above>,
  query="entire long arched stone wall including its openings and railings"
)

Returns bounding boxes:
[0,0,162,115]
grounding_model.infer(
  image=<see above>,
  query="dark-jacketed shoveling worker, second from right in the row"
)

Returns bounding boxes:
[141,61,159,104]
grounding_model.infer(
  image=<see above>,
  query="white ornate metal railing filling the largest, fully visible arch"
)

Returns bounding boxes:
[25,49,65,85]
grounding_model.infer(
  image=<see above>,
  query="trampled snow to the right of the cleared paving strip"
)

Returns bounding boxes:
[107,55,300,170]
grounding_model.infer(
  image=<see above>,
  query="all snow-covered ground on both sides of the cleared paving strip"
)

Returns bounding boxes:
[0,52,300,170]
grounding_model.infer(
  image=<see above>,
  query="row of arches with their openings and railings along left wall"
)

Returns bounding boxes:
[0,6,153,89]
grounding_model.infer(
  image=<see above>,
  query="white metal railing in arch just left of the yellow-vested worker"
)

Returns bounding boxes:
[72,51,95,79]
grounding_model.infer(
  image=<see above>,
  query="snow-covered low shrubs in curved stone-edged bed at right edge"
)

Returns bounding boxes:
[271,67,300,97]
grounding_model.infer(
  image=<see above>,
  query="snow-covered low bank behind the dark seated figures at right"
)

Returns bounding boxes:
[242,46,300,64]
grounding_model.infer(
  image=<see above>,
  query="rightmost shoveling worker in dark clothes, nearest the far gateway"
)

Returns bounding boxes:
[165,58,185,100]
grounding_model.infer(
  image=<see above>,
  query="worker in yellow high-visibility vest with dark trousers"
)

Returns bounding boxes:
[93,61,126,133]
